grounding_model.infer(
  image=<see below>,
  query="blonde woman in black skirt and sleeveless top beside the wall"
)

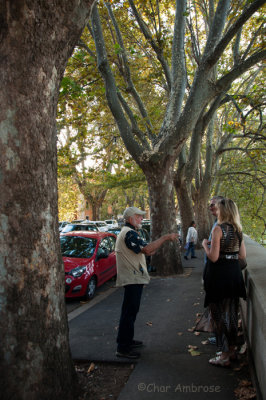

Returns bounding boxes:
[202,199,246,367]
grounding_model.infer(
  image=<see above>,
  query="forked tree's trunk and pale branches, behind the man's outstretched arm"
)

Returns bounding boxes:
[91,0,265,274]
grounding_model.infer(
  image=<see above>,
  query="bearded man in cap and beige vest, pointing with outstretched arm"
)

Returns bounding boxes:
[115,207,178,359]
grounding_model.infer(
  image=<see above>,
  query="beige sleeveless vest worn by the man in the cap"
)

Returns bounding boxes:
[115,226,150,286]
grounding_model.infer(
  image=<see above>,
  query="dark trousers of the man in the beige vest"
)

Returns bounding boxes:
[116,284,143,352]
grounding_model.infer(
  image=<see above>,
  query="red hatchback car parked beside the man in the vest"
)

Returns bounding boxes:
[60,231,116,299]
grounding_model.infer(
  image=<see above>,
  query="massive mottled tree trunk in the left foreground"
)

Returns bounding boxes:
[0,0,92,400]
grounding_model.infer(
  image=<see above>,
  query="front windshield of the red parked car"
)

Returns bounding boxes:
[60,236,97,258]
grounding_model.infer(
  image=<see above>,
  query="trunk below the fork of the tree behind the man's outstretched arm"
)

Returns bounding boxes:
[144,165,183,275]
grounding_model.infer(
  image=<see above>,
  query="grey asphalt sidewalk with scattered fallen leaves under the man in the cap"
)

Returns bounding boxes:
[69,251,245,400]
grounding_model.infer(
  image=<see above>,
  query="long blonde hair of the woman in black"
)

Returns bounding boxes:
[217,199,242,232]
